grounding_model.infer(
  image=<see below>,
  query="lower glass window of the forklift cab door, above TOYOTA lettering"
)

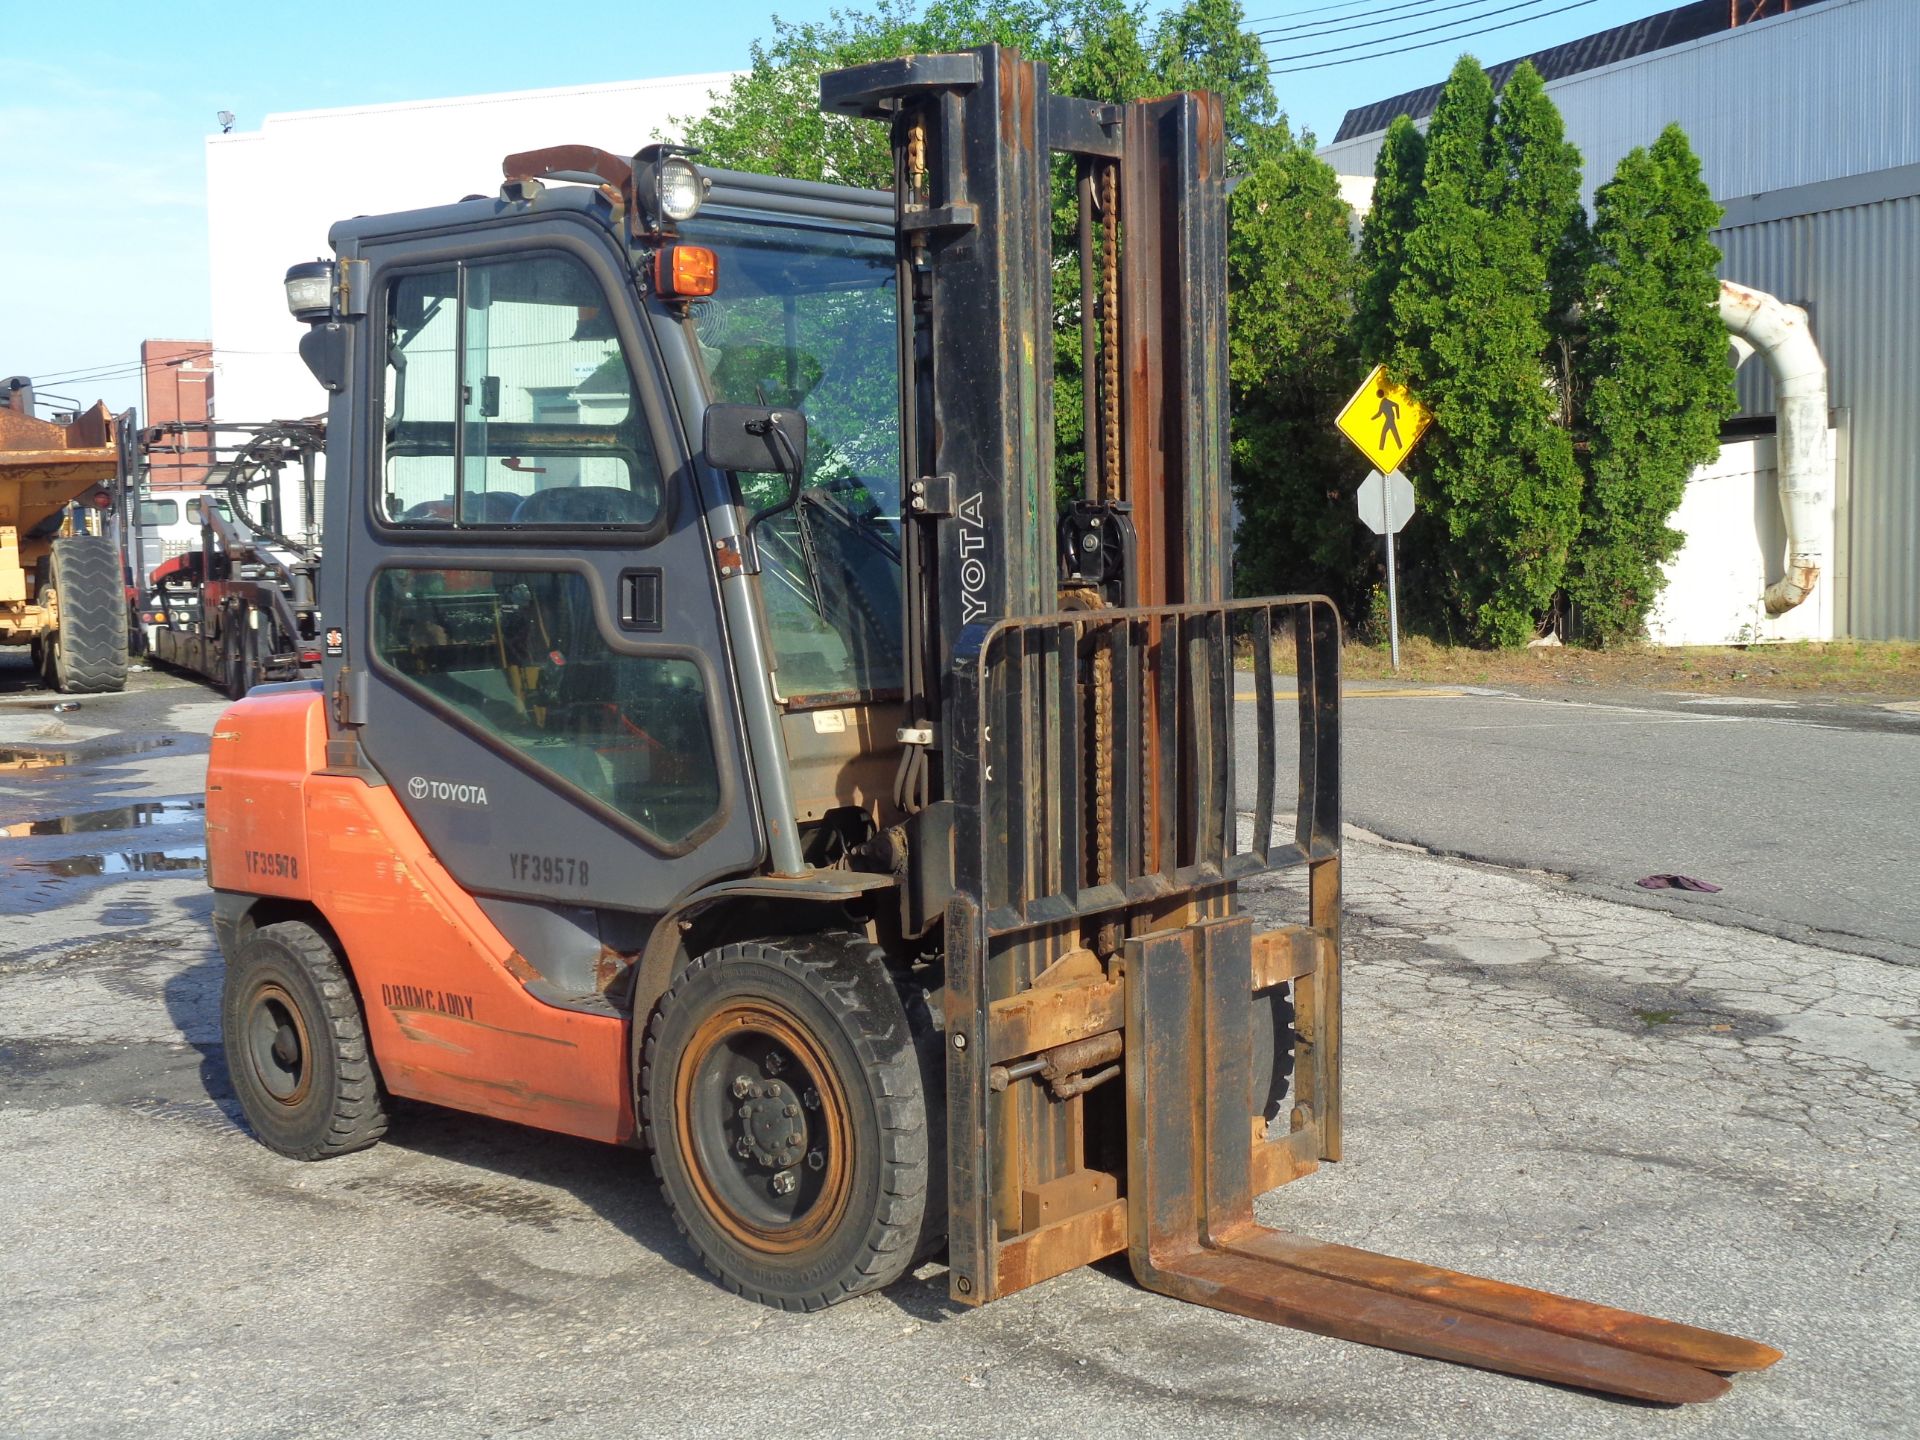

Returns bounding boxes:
[374,568,720,843]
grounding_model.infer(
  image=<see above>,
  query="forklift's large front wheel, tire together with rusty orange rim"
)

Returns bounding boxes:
[641,931,945,1309]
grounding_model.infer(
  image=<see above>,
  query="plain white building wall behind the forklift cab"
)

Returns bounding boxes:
[207,73,732,432]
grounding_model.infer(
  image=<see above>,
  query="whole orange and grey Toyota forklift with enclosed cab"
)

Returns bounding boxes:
[207,46,1778,1404]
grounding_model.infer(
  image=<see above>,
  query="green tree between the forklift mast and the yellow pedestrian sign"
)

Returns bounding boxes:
[1227,121,1377,602]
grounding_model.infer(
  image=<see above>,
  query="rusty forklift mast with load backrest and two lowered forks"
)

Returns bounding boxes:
[822,46,1778,1402]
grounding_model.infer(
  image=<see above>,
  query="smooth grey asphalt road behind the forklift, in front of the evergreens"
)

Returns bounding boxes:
[1236,685,1920,964]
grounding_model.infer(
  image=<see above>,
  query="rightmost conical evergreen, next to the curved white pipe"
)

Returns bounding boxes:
[1567,125,1736,641]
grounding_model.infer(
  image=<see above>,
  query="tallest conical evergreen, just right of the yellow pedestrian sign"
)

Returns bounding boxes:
[1386,56,1580,645]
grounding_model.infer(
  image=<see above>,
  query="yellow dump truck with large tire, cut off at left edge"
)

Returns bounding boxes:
[0,374,129,695]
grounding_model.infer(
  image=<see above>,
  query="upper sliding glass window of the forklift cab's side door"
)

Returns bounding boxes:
[382,253,664,528]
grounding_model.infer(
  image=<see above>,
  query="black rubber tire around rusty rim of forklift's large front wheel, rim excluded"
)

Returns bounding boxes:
[641,931,947,1309]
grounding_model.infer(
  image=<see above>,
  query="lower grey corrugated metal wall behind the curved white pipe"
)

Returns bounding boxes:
[1716,196,1920,639]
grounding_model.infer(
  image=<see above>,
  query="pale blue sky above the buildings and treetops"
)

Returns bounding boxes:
[0,0,1678,409]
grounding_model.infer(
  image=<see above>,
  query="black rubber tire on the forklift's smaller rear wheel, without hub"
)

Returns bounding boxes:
[221,920,386,1160]
